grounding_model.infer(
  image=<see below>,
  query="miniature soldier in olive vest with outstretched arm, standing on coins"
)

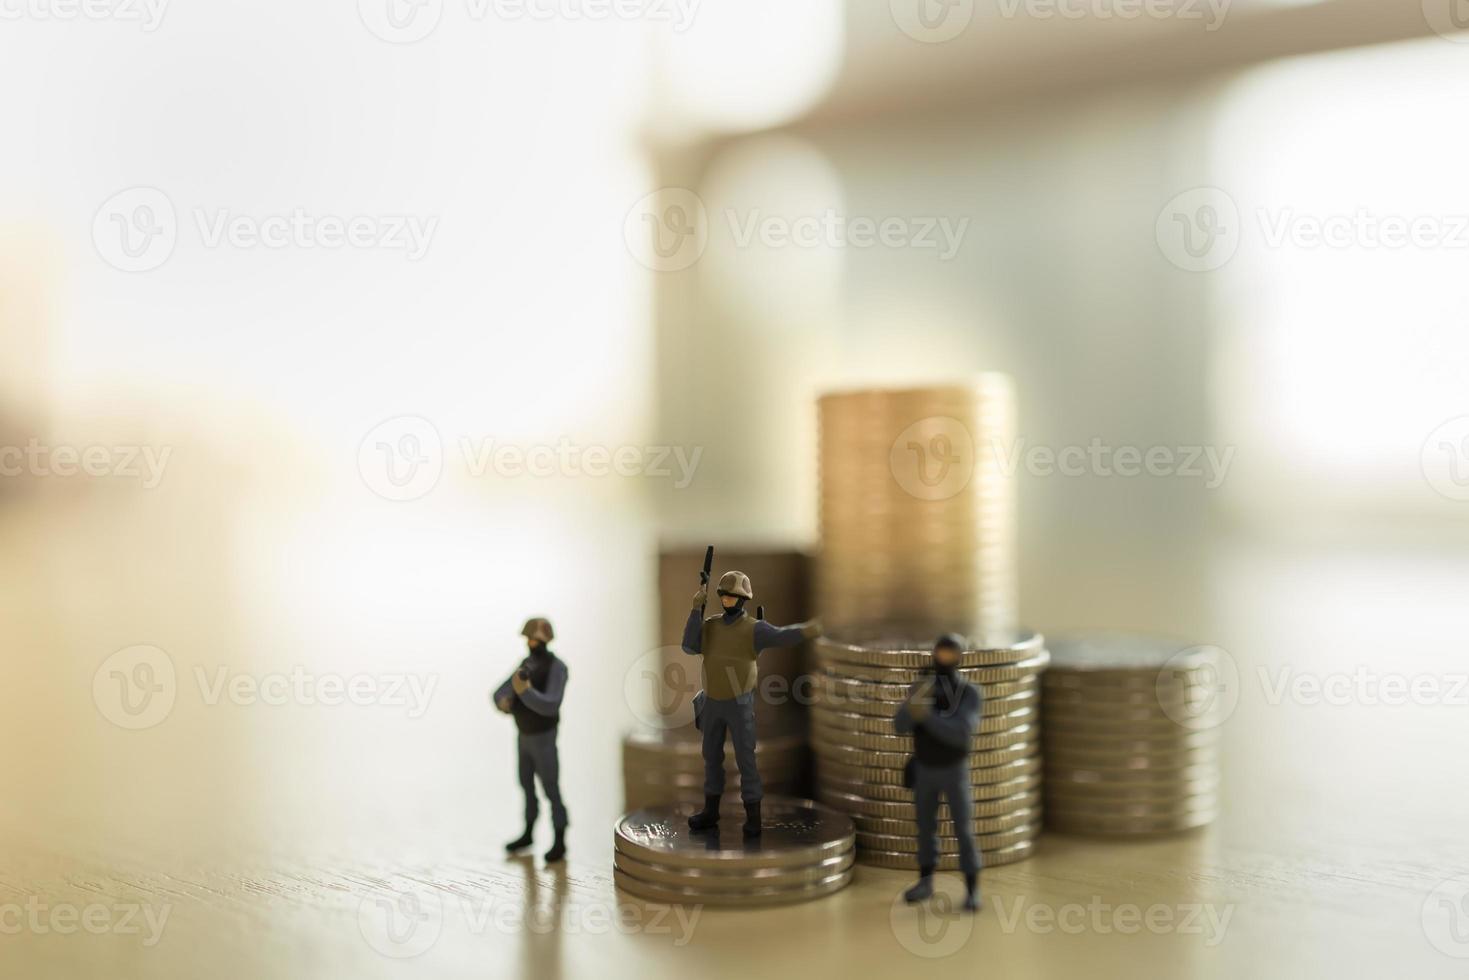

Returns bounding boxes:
[683,572,821,837]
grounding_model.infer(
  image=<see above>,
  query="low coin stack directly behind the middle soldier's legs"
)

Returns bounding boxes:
[623,732,809,810]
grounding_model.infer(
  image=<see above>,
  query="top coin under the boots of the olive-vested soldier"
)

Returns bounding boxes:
[614,796,855,868]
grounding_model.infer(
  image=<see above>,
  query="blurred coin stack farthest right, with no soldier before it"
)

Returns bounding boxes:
[1042,635,1219,835]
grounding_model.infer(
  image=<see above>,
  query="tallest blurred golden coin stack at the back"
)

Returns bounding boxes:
[815,375,1017,636]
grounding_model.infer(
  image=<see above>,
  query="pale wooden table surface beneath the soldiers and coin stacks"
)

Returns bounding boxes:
[0,469,1469,980]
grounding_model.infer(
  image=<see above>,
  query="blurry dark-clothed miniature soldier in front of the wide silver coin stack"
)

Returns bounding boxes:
[893,633,981,912]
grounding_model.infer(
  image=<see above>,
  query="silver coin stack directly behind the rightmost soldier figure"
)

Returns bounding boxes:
[811,633,1049,870]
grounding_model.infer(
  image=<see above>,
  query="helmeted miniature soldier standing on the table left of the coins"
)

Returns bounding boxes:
[495,617,567,861]
